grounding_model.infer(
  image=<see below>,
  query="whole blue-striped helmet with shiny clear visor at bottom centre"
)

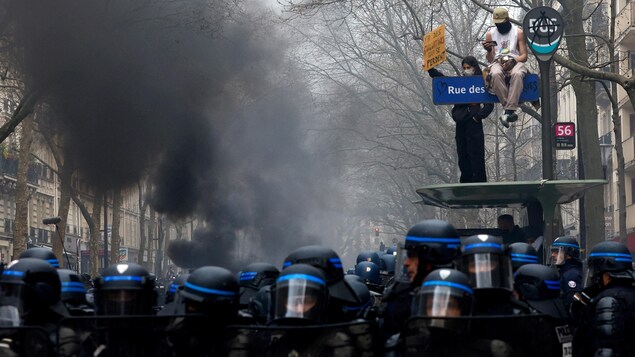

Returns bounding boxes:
[273,264,329,325]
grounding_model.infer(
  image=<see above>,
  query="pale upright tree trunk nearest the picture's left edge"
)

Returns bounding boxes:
[13,115,33,260]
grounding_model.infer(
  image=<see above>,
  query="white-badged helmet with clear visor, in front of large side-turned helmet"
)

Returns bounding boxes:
[411,269,474,329]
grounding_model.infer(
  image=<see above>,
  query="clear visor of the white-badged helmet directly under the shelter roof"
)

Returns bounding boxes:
[461,253,513,291]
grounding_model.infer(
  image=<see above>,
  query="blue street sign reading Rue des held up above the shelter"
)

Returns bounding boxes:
[432,74,539,105]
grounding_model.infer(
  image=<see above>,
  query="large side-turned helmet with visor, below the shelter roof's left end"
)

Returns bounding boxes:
[395,219,461,286]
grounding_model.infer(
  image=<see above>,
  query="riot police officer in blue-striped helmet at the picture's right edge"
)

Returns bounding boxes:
[573,242,635,356]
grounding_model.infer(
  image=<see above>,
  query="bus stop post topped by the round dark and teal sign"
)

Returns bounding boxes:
[523,6,564,261]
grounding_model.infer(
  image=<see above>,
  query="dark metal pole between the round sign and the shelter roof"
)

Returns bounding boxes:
[538,61,553,180]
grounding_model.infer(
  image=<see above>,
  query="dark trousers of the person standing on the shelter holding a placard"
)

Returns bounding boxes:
[454,119,487,183]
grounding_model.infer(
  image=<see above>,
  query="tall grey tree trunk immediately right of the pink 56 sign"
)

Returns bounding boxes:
[560,0,604,249]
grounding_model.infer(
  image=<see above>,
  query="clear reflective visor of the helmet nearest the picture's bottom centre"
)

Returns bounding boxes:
[274,278,327,322]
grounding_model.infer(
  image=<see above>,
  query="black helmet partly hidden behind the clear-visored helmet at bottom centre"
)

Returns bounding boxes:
[282,245,359,304]
